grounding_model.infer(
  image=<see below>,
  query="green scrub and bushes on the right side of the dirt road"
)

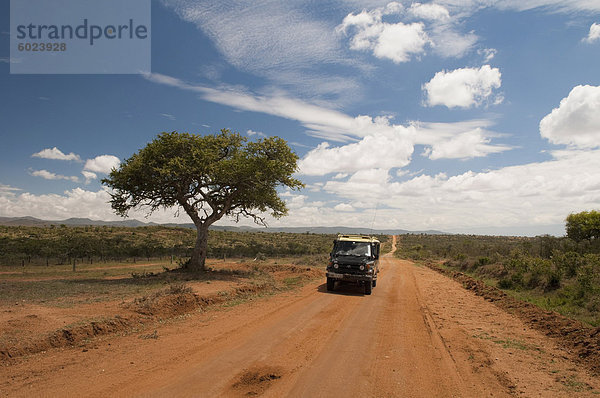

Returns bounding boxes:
[396,212,600,326]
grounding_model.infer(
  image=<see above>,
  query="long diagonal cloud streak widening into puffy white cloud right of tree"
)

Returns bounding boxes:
[145,74,508,169]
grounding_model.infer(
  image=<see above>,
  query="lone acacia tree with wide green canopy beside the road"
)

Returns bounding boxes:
[102,129,303,270]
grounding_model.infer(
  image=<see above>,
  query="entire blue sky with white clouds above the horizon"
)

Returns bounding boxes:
[0,0,600,235]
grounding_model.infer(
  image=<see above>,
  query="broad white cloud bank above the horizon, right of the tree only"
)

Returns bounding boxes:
[314,151,600,231]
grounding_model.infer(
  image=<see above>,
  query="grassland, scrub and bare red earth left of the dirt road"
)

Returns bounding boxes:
[0,226,389,358]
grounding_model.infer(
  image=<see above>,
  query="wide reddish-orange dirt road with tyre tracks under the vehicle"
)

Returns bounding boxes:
[0,238,600,397]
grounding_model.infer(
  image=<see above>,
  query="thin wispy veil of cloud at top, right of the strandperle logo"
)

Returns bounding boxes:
[163,0,357,100]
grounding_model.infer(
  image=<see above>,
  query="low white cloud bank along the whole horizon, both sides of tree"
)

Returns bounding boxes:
[7,150,600,233]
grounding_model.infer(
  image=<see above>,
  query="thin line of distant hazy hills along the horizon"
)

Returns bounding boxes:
[0,216,446,235]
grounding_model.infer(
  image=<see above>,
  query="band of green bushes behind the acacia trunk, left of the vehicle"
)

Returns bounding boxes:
[0,226,334,266]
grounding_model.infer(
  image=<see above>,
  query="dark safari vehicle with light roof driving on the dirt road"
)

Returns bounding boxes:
[327,234,380,294]
